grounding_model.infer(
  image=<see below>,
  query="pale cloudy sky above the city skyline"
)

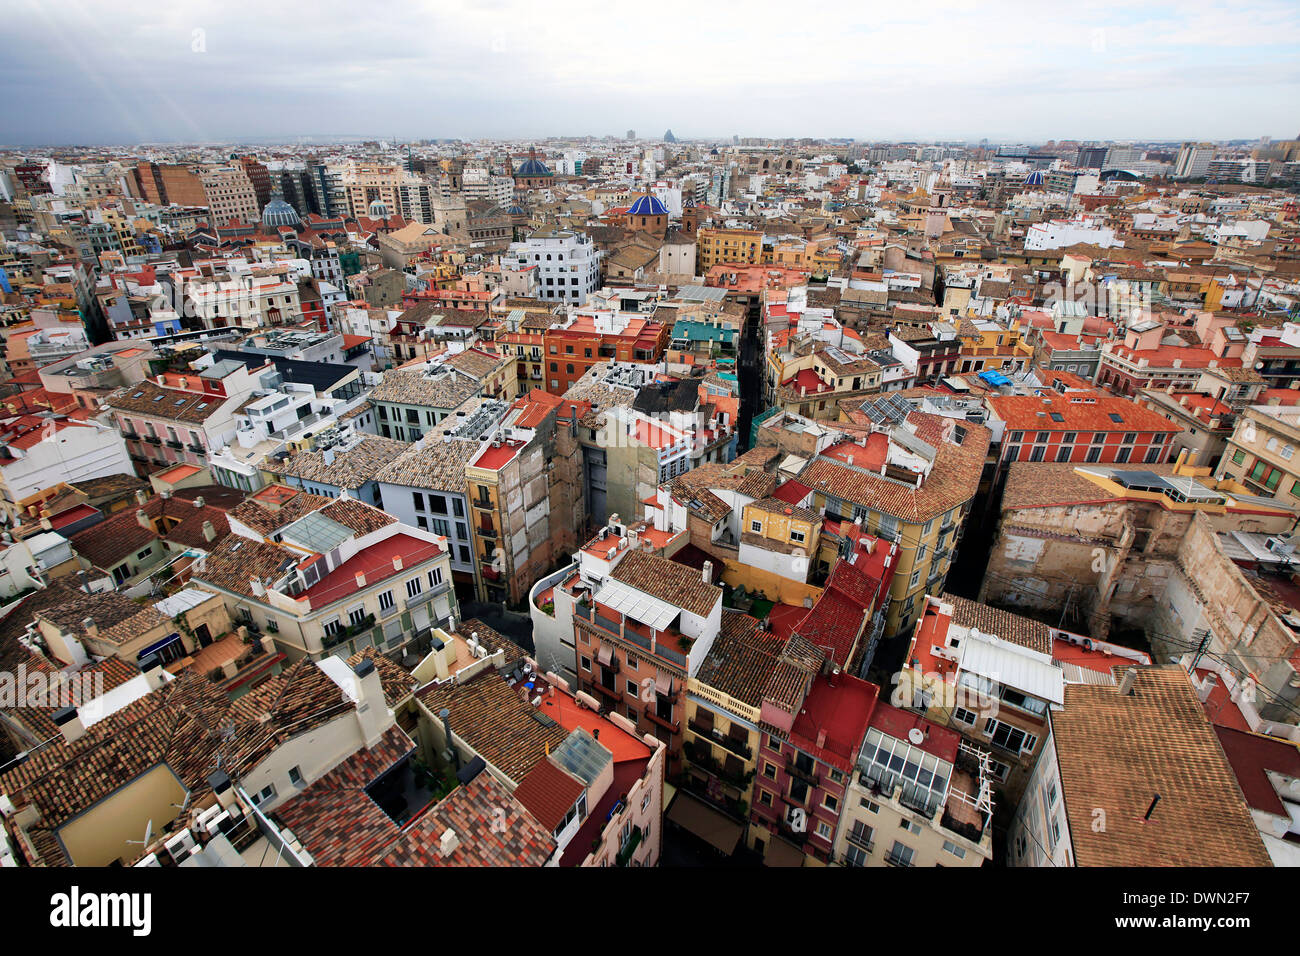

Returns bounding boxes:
[0,0,1300,144]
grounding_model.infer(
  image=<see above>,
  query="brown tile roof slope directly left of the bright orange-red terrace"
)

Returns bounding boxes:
[416,667,568,780]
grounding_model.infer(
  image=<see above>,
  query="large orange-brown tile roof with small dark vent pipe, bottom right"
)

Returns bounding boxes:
[1052,665,1271,866]
